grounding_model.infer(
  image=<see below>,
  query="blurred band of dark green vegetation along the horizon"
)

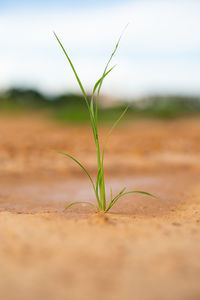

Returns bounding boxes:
[0,88,200,122]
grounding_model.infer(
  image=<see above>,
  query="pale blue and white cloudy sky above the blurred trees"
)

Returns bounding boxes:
[0,0,200,97]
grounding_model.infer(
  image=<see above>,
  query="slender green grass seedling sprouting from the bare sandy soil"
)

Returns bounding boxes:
[54,32,154,212]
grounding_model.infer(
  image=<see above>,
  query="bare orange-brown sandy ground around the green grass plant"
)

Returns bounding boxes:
[0,115,200,300]
